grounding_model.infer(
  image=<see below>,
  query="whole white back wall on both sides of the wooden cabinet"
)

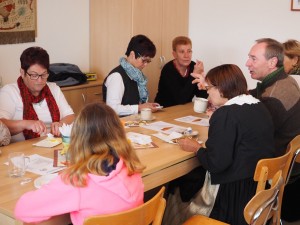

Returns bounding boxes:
[0,0,300,87]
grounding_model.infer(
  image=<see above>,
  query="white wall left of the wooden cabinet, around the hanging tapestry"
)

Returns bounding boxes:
[0,0,89,84]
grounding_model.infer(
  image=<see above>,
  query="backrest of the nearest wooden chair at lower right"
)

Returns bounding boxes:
[244,170,284,225]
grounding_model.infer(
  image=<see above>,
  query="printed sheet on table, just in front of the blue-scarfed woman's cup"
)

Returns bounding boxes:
[141,121,187,134]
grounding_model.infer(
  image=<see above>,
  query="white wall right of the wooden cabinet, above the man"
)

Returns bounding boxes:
[189,0,300,88]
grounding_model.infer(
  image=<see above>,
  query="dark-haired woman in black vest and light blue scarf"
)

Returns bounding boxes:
[103,35,159,116]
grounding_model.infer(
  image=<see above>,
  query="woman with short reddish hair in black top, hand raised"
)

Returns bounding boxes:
[155,36,207,107]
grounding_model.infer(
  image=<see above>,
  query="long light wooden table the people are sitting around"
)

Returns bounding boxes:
[0,103,208,225]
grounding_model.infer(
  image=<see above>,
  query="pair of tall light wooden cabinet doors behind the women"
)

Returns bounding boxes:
[90,0,189,102]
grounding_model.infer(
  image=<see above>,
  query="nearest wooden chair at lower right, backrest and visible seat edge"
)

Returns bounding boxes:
[183,170,284,225]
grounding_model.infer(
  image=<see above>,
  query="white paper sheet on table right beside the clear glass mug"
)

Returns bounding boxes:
[26,154,64,175]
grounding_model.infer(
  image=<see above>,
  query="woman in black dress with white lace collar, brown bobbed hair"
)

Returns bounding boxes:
[165,64,275,225]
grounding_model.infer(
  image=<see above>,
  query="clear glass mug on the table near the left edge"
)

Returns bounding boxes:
[7,152,30,177]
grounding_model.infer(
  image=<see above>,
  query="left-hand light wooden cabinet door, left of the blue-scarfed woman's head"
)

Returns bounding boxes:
[90,0,132,79]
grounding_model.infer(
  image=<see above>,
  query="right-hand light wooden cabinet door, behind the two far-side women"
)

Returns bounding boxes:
[132,0,189,102]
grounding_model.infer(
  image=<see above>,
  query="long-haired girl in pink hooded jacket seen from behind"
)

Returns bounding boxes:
[15,103,144,225]
